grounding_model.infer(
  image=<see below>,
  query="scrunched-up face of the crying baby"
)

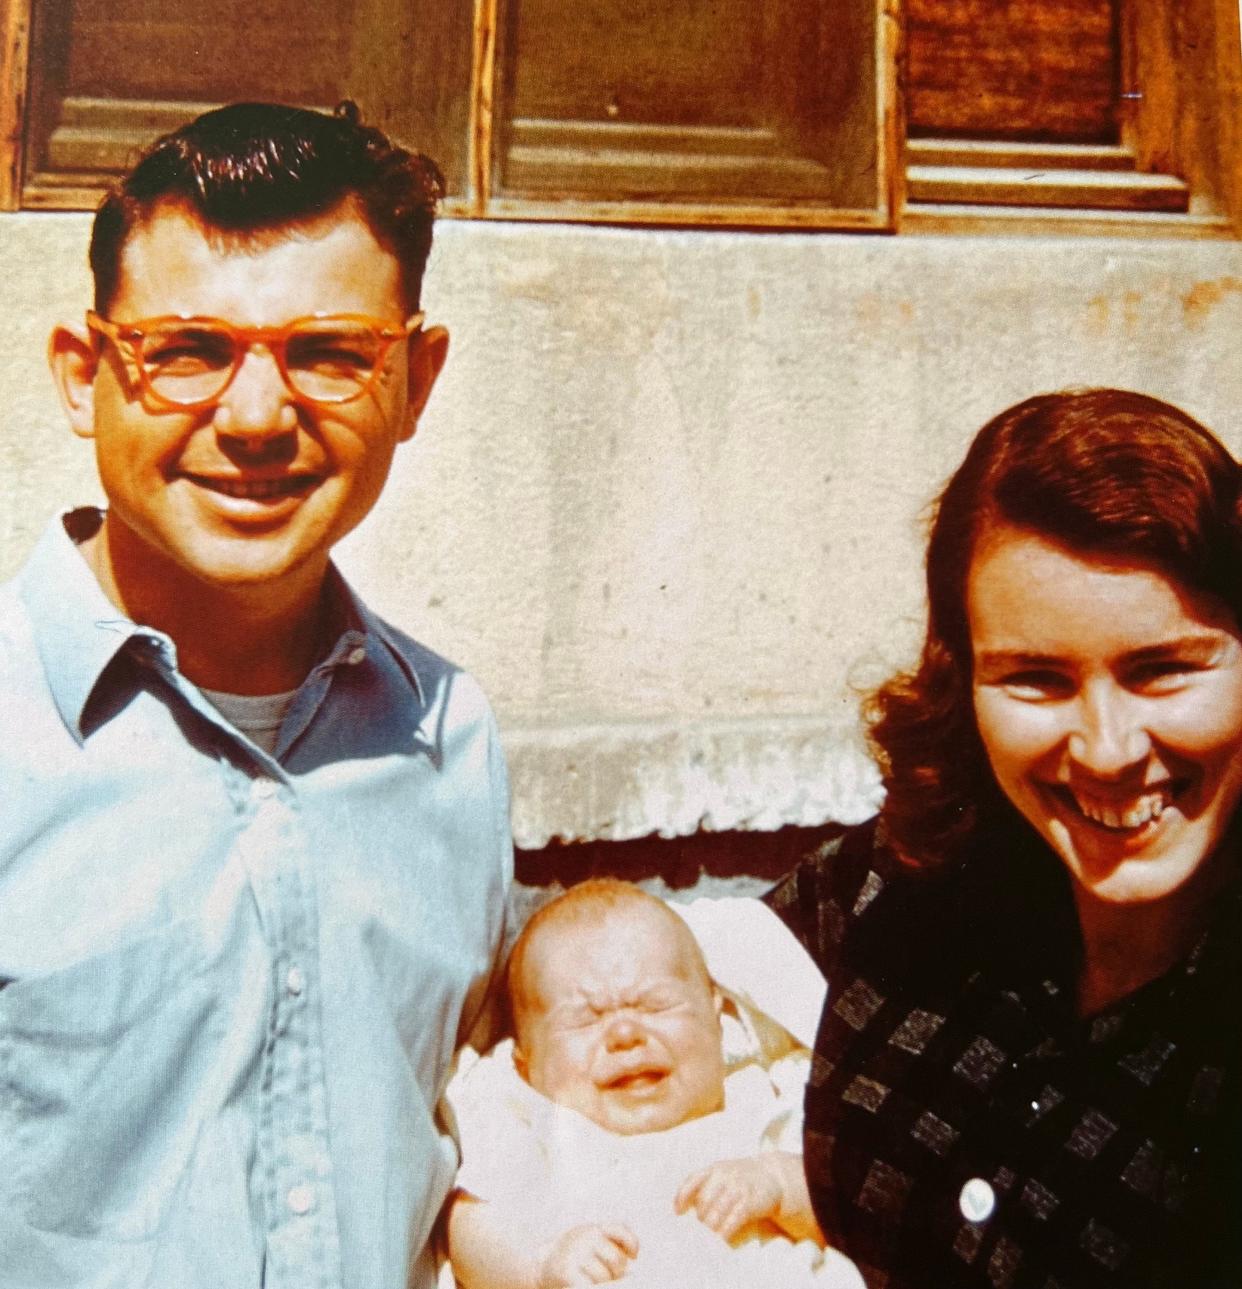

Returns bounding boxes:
[522,905,724,1134]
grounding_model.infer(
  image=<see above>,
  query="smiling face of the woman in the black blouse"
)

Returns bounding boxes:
[966,526,1242,904]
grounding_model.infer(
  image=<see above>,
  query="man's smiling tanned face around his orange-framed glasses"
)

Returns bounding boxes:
[60,206,447,590]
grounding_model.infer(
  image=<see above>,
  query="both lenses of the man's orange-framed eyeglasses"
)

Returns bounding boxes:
[142,318,387,403]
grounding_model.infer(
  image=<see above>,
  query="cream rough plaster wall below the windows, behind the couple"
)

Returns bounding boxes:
[0,214,1242,846]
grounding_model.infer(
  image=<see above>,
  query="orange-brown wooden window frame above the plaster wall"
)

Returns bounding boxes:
[0,0,1242,238]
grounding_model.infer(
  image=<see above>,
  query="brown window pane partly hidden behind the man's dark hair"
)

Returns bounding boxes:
[26,0,473,193]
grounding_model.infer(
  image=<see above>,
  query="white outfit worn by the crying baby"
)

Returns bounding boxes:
[448,1040,863,1289]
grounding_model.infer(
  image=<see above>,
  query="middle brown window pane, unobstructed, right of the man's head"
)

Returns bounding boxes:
[495,0,883,210]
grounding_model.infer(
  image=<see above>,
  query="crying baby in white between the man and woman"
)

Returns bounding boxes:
[448,880,862,1289]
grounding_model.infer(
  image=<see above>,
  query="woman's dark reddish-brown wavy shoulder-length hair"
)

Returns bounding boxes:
[866,389,1242,865]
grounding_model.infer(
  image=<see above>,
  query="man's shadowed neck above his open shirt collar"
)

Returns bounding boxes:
[79,523,327,695]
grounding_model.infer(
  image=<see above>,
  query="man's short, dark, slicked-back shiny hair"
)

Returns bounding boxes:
[90,99,444,316]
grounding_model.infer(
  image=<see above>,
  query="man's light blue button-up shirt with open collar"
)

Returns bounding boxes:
[0,512,511,1289]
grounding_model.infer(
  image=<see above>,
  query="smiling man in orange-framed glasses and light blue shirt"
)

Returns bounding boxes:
[0,104,511,1289]
